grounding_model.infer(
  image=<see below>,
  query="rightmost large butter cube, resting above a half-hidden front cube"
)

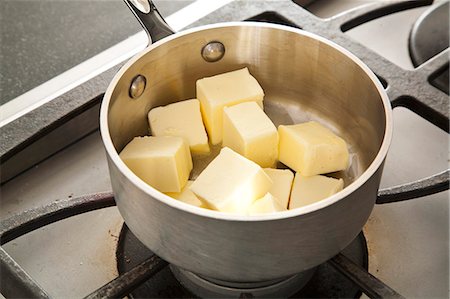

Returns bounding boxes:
[278,121,349,176]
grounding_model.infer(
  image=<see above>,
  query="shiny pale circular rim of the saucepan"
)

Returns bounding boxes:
[100,22,393,222]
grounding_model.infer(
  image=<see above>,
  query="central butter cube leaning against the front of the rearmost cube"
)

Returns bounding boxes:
[222,102,278,167]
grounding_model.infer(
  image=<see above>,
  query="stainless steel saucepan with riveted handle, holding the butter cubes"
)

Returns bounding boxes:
[100,0,392,282]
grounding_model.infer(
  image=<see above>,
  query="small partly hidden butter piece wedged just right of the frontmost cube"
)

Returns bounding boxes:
[264,168,294,208]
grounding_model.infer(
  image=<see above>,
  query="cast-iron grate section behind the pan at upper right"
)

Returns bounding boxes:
[222,0,450,132]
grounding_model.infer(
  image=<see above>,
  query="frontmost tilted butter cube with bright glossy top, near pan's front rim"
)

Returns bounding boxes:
[191,147,272,214]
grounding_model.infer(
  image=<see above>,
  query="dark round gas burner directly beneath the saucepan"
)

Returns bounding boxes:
[116,224,368,298]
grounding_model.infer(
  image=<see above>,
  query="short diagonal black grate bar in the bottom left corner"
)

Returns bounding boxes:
[0,247,49,298]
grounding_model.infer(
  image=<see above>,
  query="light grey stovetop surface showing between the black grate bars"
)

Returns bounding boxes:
[0,1,449,298]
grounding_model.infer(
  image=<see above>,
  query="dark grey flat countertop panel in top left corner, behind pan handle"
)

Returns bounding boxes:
[0,0,193,105]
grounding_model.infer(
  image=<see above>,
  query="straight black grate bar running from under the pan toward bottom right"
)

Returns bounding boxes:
[328,253,404,299]
